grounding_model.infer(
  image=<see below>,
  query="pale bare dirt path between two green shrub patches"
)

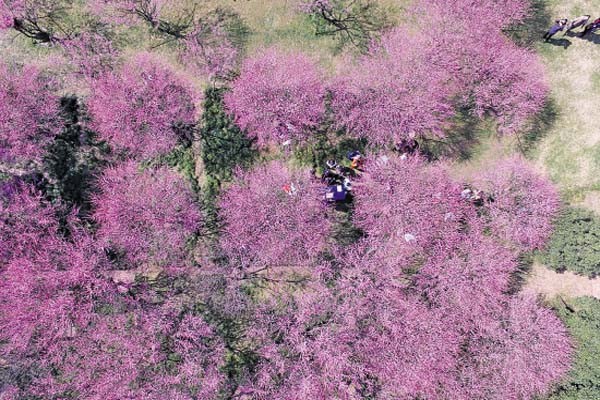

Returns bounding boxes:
[523,262,600,299]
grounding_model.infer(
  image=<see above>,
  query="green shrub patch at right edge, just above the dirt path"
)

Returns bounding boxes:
[542,208,600,278]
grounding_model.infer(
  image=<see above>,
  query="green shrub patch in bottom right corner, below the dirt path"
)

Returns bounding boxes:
[547,297,600,400]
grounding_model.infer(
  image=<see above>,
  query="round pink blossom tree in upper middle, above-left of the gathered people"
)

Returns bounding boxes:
[225,49,325,147]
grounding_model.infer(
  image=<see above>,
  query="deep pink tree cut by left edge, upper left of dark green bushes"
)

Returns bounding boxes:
[0,64,60,175]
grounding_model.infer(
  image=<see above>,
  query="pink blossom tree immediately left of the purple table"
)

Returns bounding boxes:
[219,161,331,274]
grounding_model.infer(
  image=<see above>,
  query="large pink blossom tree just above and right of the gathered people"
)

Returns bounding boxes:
[331,28,455,145]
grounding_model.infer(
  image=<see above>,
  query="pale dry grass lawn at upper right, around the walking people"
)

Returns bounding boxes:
[533,0,600,205]
